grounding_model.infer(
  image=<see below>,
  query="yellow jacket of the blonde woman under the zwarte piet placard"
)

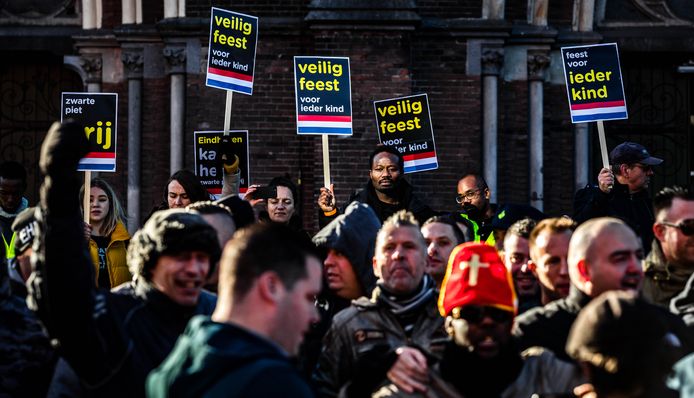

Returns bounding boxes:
[89,221,132,287]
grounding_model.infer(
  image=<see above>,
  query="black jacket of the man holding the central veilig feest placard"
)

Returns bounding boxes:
[318,177,436,228]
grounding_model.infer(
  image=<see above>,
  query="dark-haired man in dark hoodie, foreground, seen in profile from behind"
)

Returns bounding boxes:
[147,223,321,398]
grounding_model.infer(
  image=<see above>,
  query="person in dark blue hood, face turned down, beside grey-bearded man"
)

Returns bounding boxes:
[299,202,381,377]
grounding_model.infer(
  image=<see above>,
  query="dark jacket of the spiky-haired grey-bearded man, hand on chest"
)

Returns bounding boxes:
[313,286,448,397]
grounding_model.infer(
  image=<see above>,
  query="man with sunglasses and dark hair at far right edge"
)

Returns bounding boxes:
[642,186,694,307]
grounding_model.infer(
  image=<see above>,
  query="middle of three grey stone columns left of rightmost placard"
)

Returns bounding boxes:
[528,50,550,211]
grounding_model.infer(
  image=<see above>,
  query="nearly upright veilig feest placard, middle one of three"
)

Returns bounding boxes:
[294,57,352,135]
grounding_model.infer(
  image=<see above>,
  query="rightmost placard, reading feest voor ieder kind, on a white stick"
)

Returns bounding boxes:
[561,43,628,123]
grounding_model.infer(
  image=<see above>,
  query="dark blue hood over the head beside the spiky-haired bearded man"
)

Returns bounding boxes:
[313,202,381,296]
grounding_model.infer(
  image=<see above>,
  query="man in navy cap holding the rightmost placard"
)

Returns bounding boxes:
[573,142,663,252]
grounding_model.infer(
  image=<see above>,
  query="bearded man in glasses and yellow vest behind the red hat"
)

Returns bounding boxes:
[455,174,498,246]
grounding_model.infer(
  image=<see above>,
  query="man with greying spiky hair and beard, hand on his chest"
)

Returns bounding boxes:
[313,210,446,397]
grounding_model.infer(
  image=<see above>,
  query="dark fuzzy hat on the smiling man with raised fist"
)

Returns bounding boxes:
[128,209,221,280]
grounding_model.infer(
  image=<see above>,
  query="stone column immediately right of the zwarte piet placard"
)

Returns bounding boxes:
[121,48,144,235]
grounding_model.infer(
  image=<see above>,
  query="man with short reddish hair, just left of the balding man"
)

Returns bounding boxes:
[528,217,576,305]
